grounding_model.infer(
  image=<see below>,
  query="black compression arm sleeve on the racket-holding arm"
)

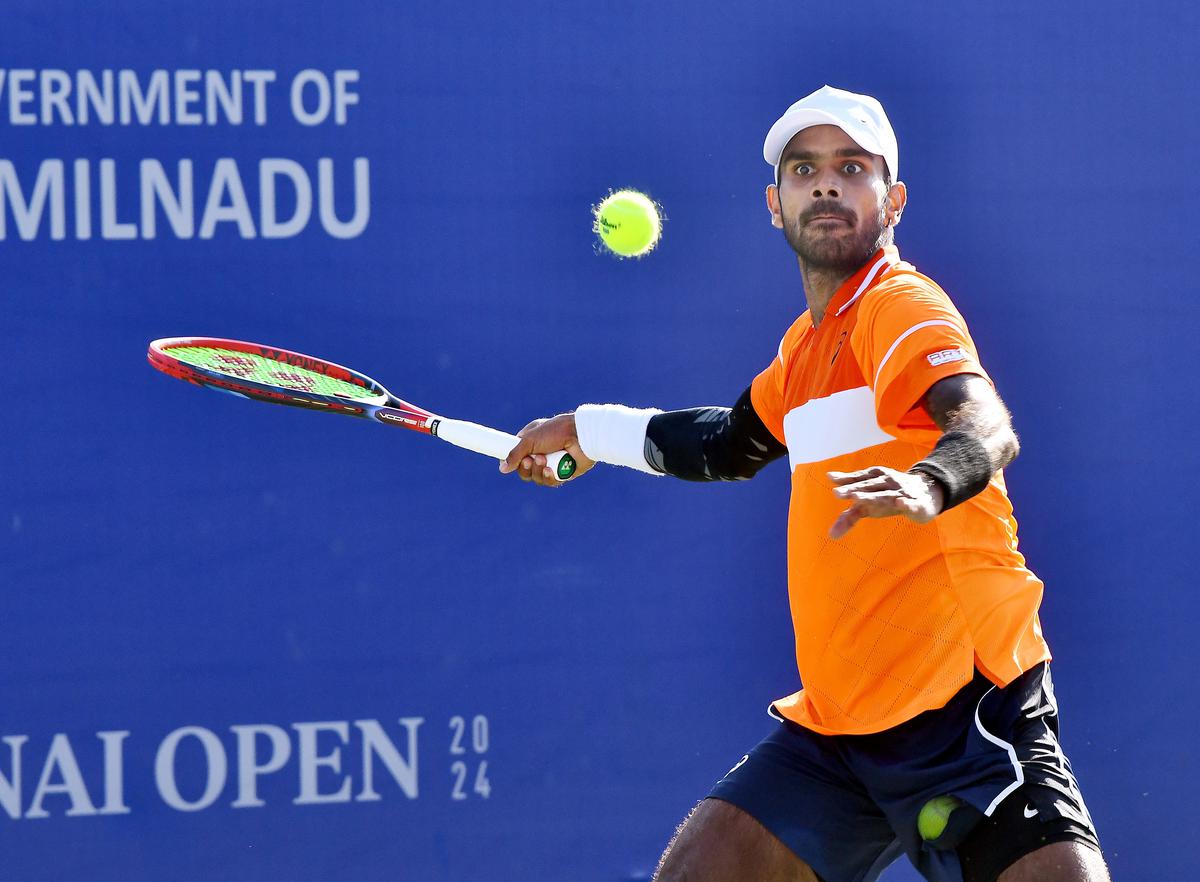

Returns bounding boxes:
[646,389,787,481]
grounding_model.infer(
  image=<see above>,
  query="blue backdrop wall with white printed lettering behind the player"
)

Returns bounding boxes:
[0,0,1200,882]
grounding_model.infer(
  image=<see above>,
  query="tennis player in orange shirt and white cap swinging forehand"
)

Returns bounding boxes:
[500,86,1109,882]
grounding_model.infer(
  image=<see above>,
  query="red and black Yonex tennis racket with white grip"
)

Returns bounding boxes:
[146,337,576,481]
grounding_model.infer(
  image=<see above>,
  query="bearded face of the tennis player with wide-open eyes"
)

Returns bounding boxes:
[767,126,904,271]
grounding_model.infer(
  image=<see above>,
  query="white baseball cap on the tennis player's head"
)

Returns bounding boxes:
[762,85,900,181]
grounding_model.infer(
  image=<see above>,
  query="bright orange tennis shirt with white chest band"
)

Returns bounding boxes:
[750,247,1050,734]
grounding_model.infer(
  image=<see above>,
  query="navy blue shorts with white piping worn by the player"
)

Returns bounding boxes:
[709,664,1100,882]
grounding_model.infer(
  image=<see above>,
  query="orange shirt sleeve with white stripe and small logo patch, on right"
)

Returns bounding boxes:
[851,276,991,434]
